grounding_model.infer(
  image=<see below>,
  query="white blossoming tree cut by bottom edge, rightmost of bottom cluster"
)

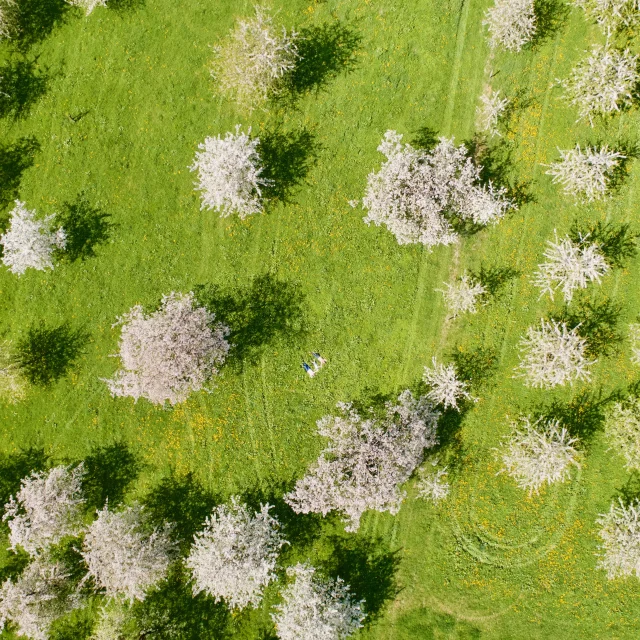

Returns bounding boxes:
[272,564,365,640]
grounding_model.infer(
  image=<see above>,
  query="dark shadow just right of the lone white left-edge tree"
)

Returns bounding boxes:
[56,197,115,262]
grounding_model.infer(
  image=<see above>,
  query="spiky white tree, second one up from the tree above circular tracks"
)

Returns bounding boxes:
[533,231,609,302]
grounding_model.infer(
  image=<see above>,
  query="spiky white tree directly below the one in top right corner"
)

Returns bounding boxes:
[561,45,640,126]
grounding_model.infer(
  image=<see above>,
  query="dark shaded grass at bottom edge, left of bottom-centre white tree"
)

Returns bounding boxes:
[131,563,232,640]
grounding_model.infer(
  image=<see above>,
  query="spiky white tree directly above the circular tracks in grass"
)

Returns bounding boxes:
[500,417,580,494]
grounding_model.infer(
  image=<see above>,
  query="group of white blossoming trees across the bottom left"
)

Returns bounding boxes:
[0,464,365,640]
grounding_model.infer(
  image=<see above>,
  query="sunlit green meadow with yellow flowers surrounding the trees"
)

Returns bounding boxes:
[0,0,640,640]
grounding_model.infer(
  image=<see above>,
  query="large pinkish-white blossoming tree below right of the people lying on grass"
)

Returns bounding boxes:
[285,390,440,531]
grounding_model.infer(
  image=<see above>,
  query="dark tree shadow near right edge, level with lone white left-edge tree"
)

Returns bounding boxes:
[569,220,640,268]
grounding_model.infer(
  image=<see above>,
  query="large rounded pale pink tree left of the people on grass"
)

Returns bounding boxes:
[105,292,230,404]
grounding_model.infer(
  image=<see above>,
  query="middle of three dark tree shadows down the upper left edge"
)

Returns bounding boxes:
[0,60,48,119]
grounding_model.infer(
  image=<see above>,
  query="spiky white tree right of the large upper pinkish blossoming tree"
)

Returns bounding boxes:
[546,144,625,202]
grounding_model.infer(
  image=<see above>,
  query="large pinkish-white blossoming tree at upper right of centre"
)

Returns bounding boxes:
[362,131,515,247]
